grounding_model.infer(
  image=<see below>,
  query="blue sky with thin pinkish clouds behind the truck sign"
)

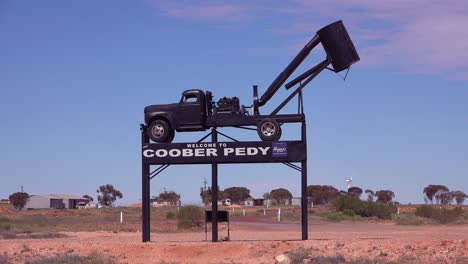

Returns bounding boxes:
[0,0,468,204]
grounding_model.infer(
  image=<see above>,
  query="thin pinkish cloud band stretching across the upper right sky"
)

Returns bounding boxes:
[151,0,468,80]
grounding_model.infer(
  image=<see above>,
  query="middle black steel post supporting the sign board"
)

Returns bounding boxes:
[211,128,218,242]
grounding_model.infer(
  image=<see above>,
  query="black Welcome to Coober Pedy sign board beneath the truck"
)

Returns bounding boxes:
[142,141,307,165]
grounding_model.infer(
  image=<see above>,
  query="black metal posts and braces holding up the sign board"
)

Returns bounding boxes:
[140,115,308,242]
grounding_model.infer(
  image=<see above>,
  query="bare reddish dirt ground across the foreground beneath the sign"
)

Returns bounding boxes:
[0,222,468,263]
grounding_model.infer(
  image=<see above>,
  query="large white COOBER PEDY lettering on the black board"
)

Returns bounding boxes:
[143,147,270,158]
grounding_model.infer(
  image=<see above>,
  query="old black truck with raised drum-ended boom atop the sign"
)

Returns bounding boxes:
[144,21,359,143]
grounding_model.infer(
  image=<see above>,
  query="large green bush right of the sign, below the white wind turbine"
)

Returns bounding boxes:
[332,195,397,219]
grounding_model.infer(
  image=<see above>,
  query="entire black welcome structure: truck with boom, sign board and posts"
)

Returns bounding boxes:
[141,20,360,242]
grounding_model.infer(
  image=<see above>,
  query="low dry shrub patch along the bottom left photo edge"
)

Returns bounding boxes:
[25,251,116,264]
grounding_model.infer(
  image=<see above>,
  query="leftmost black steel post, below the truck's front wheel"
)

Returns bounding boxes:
[141,128,151,242]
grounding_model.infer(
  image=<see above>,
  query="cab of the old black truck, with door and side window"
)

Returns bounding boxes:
[177,90,206,126]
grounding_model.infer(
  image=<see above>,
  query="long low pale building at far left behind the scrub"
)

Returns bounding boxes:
[25,194,89,209]
